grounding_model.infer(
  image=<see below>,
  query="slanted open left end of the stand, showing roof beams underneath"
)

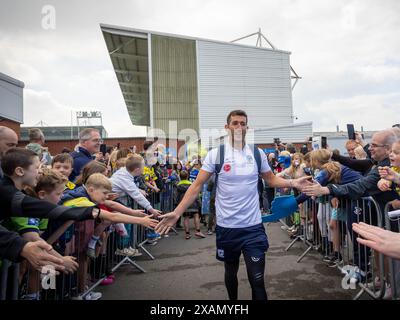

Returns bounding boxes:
[100,25,150,126]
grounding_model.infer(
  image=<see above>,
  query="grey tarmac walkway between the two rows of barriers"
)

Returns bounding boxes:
[99,223,355,300]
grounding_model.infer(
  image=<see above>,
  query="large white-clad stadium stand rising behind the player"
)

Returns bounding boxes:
[100,24,312,147]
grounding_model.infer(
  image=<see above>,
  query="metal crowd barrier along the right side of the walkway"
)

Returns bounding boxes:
[281,192,388,299]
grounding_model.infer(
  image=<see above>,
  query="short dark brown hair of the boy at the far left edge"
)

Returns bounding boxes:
[1,148,37,176]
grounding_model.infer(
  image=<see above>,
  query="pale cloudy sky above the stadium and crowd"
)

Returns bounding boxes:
[0,0,400,137]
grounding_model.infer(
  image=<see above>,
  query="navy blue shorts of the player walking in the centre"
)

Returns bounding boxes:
[215,223,269,262]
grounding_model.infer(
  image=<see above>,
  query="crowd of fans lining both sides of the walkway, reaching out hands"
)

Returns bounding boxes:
[0,127,400,300]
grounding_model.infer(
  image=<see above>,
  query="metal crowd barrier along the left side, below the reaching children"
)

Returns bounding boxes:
[0,184,177,300]
